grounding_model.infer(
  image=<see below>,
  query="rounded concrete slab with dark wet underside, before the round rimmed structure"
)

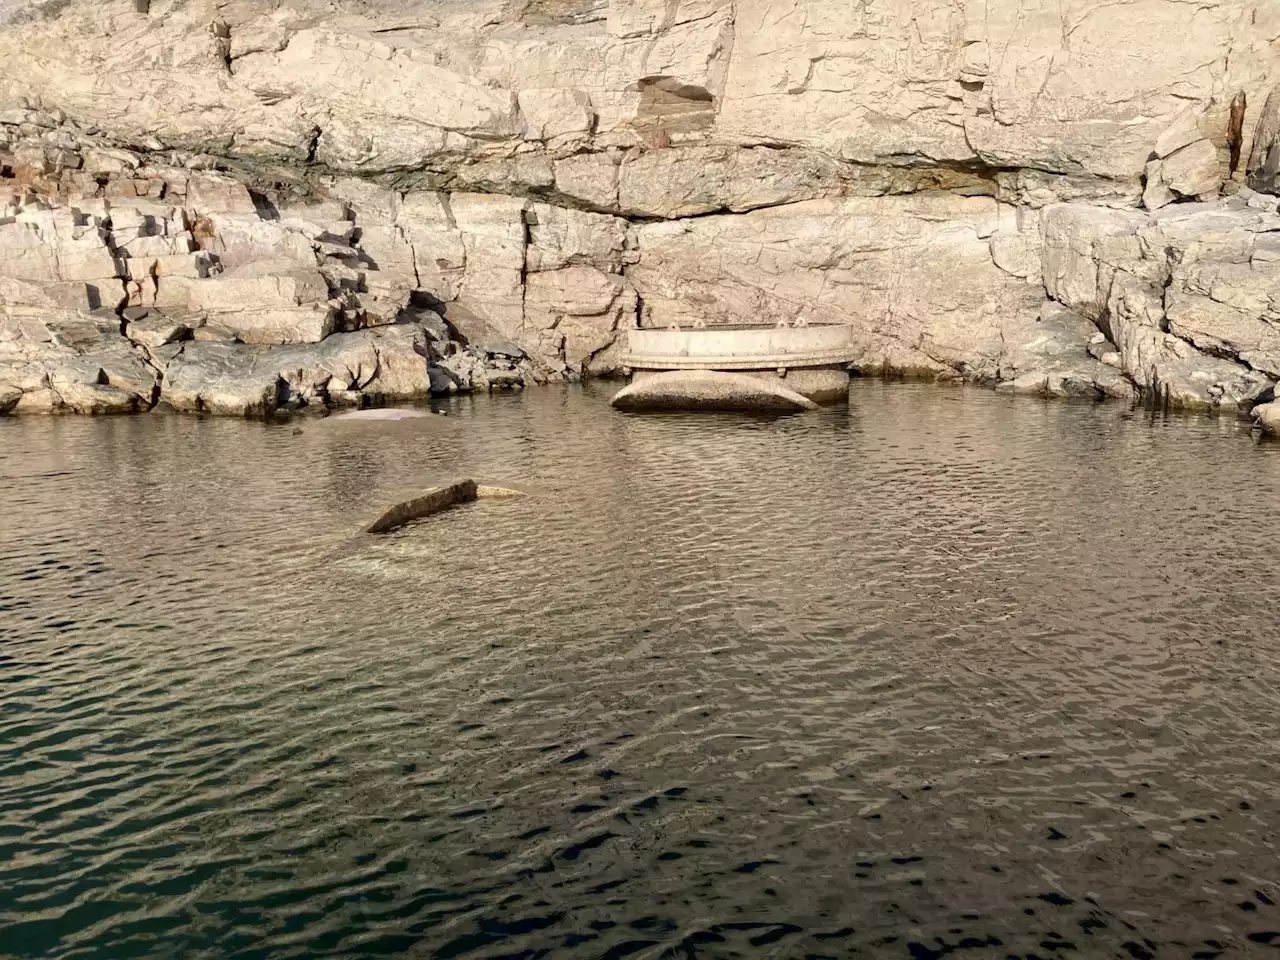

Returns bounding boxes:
[612,370,818,413]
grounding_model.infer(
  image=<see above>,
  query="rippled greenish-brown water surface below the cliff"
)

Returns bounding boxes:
[0,383,1280,960]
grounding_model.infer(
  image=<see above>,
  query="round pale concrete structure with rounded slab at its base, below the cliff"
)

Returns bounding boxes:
[613,324,855,410]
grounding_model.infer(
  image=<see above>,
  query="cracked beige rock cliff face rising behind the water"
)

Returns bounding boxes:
[0,0,1280,412]
